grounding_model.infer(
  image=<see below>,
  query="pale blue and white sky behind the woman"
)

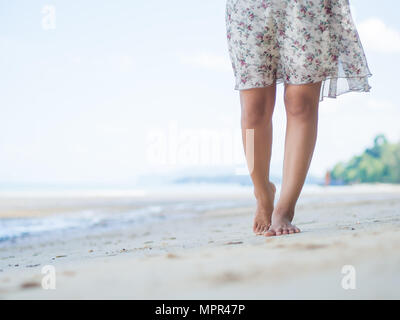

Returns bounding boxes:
[0,0,400,185]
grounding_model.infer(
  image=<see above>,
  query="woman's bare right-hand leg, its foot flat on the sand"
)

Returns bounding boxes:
[266,82,321,236]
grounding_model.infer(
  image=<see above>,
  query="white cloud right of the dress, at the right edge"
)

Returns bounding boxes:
[358,18,400,53]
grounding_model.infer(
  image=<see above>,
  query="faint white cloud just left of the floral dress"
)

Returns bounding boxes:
[180,52,232,71]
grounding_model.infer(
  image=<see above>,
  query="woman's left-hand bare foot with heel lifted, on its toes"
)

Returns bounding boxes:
[253,182,276,234]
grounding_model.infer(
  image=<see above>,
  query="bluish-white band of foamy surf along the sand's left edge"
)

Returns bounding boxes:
[0,185,252,245]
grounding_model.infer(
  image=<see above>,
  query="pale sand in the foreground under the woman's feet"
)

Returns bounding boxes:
[0,188,400,299]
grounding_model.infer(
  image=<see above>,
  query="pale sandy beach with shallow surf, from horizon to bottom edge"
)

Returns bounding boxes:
[0,184,400,299]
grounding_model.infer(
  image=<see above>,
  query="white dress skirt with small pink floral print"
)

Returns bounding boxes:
[225,0,371,100]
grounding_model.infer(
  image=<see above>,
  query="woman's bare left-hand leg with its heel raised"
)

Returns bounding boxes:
[240,84,276,233]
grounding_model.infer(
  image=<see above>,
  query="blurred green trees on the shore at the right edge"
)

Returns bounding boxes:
[330,134,400,184]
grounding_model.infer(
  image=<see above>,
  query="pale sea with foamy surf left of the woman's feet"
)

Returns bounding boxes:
[0,183,323,247]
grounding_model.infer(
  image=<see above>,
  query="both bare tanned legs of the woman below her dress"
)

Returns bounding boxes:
[240,82,321,236]
